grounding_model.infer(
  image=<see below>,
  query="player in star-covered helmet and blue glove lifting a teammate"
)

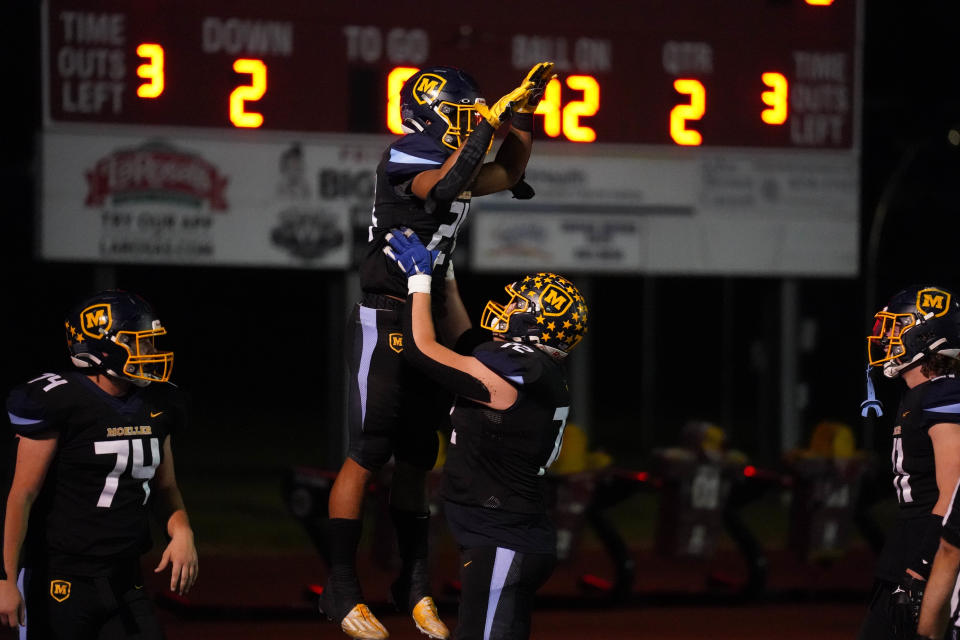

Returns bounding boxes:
[385,229,587,640]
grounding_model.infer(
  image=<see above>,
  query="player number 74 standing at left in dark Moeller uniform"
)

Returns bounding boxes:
[0,290,197,640]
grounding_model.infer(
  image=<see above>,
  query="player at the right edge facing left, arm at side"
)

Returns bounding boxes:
[858,286,960,640]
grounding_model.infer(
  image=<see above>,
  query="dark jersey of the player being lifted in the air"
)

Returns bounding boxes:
[360,133,470,303]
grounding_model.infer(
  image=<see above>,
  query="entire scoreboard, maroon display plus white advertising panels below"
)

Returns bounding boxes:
[40,0,863,276]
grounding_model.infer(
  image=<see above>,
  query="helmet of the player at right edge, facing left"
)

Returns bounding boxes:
[867,286,960,378]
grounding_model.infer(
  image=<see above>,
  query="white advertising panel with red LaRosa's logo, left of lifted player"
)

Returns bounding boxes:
[40,133,385,269]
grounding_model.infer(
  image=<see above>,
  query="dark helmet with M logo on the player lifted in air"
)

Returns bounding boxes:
[400,67,484,151]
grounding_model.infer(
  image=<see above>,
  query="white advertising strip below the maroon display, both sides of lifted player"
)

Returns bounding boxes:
[41,132,859,276]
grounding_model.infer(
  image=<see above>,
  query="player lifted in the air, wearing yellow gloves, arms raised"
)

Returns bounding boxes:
[320,62,553,640]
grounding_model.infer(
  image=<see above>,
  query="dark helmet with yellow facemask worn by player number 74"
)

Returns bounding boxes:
[64,289,173,387]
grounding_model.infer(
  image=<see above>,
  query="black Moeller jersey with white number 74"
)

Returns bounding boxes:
[7,372,185,575]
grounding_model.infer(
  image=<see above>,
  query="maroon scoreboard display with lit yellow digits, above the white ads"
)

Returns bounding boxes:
[44,0,859,149]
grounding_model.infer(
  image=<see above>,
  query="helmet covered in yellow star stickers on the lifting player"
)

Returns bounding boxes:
[480,272,587,359]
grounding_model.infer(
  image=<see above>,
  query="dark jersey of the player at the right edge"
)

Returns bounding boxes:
[877,376,960,582]
